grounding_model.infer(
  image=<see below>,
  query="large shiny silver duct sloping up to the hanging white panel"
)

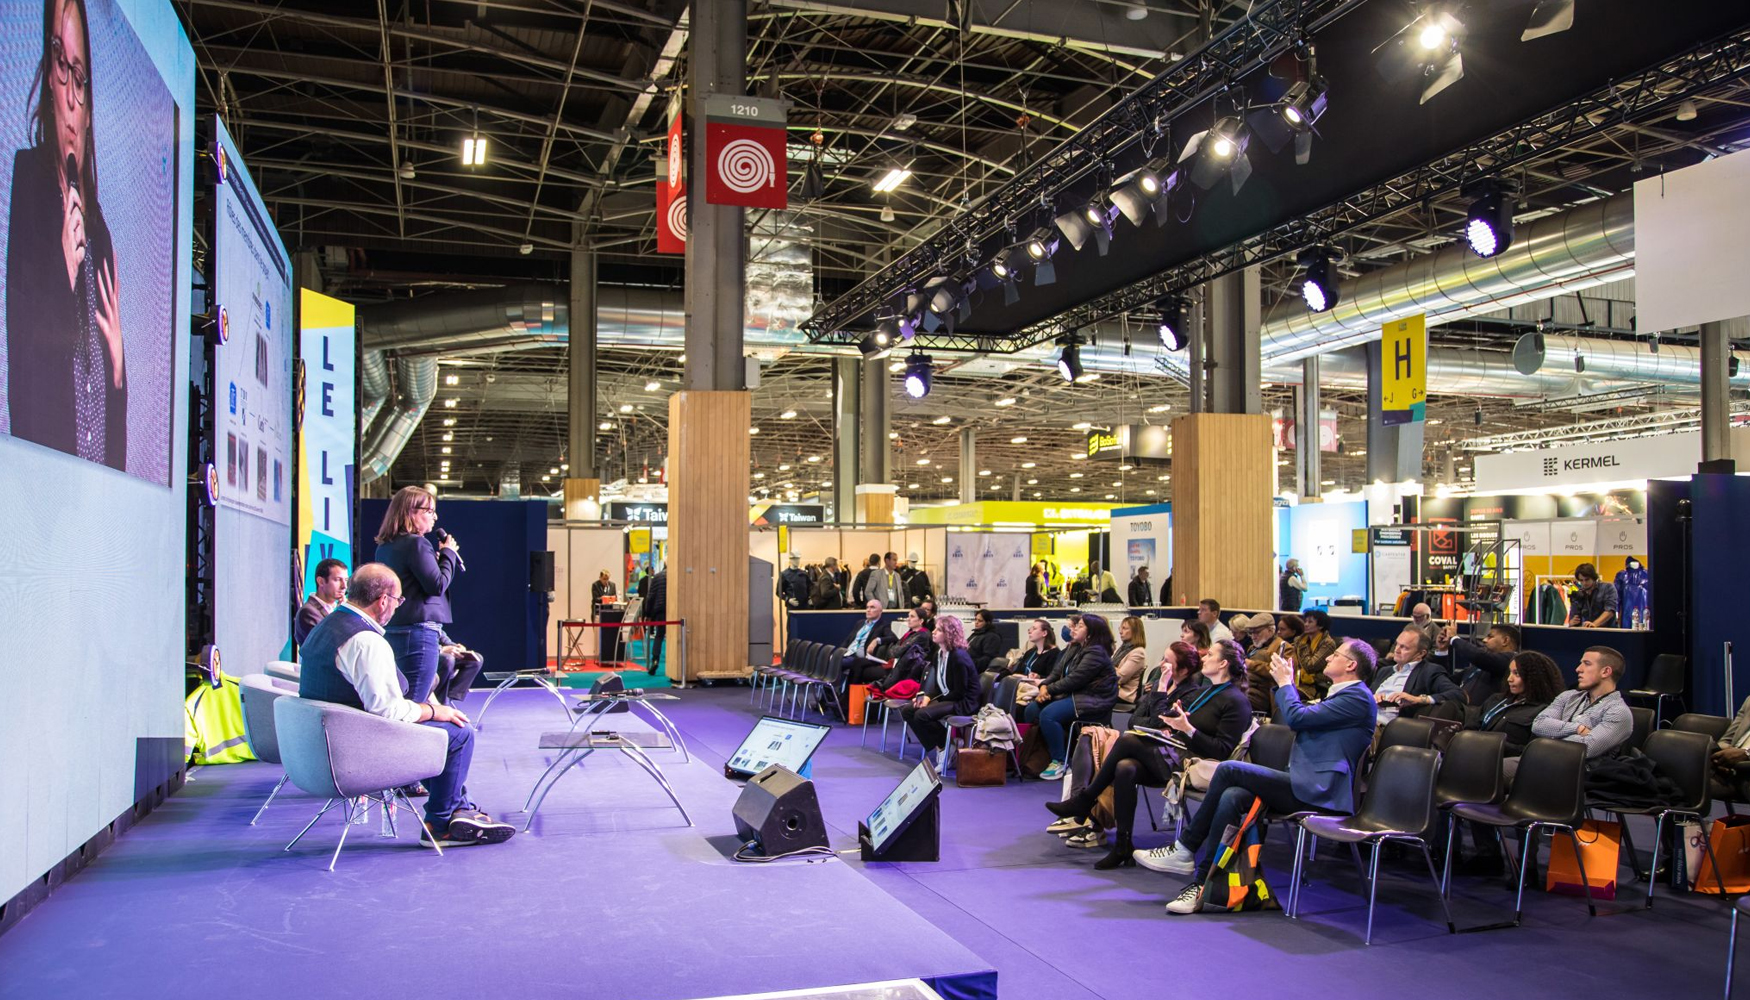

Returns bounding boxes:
[1260,194,1635,364]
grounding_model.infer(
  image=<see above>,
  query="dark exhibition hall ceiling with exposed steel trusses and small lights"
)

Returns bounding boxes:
[177,0,1750,501]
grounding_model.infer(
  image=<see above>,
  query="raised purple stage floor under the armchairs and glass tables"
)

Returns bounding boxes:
[0,688,994,1000]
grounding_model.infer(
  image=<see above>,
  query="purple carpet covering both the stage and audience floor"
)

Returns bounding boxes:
[0,688,1727,1000]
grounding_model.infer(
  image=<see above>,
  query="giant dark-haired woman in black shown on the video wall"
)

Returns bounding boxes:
[5,0,128,469]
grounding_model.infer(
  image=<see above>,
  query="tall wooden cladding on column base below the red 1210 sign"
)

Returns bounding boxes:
[663,389,753,681]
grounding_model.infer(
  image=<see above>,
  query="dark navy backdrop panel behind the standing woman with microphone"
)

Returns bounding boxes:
[355,499,546,671]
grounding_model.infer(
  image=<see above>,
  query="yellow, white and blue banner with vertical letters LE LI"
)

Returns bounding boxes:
[294,289,357,605]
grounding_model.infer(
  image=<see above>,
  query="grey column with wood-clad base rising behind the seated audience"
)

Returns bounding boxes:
[1157,270,1276,609]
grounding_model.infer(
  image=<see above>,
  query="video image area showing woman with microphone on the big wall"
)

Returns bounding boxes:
[0,0,186,479]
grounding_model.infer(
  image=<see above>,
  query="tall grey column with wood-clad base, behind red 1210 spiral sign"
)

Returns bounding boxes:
[663,0,753,680]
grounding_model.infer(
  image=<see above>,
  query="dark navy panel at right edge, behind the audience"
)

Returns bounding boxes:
[1680,475,1750,715]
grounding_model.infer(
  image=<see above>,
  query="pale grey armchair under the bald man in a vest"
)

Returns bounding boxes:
[273,697,450,872]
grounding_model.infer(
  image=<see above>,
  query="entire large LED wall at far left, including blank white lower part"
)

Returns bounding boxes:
[0,0,194,910]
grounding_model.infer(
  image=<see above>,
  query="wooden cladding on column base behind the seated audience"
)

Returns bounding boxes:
[1173,413,1276,608]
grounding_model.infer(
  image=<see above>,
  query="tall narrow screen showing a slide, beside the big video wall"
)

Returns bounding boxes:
[208,119,296,674]
